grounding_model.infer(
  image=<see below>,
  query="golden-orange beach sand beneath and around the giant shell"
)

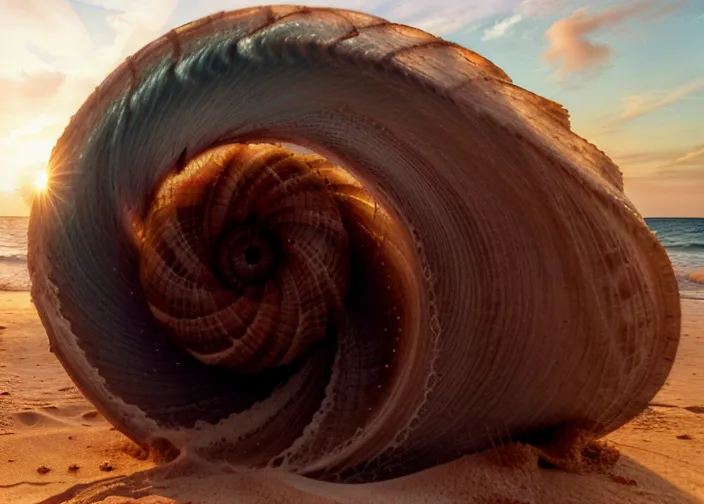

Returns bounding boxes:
[0,293,704,504]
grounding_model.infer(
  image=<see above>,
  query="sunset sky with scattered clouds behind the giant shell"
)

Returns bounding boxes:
[0,0,704,217]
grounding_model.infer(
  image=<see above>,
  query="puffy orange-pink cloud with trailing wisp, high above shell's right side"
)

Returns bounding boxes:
[543,0,682,79]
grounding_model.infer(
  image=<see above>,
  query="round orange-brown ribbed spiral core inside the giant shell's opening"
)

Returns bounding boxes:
[139,145,349,372]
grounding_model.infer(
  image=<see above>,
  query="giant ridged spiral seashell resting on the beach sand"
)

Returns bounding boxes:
[28,6,680,481]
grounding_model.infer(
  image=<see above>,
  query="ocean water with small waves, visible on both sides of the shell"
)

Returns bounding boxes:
[0,217,704,300]
